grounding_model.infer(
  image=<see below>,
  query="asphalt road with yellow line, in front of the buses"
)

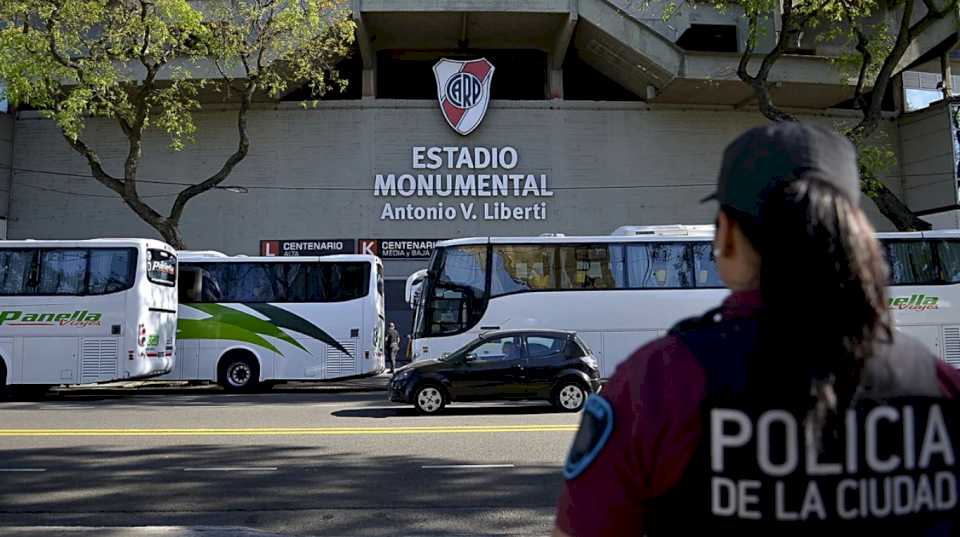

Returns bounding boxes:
[0,378,579,536]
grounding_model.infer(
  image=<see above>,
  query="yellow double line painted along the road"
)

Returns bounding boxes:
[0,424,577,437]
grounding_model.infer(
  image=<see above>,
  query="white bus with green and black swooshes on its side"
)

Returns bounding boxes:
[164,252,385,391]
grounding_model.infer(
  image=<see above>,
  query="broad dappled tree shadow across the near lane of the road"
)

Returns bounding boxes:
[0,439,561,536]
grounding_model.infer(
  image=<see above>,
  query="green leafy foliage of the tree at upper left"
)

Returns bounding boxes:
[0,0,354,150]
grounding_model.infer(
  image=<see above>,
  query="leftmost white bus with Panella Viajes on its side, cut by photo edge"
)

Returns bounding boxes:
[0,239,177,390]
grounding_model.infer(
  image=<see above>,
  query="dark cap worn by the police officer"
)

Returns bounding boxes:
[703,121,860,216]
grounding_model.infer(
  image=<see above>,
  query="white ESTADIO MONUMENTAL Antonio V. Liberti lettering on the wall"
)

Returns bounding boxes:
[373,146,553,221]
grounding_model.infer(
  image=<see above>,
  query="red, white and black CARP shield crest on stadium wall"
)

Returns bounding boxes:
[433,58,494,136]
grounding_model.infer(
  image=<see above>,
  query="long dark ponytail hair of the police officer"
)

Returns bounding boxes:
[721,178,892,418]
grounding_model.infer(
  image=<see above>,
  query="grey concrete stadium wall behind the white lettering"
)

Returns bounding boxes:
[10,100,899,276]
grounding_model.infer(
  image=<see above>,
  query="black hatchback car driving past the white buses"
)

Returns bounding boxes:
[390,330,600,414]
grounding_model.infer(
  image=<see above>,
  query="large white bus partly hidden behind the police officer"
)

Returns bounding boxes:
[406,226,960,377]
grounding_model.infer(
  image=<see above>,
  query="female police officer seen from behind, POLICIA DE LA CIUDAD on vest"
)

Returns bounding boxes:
[554,123,960,537]
